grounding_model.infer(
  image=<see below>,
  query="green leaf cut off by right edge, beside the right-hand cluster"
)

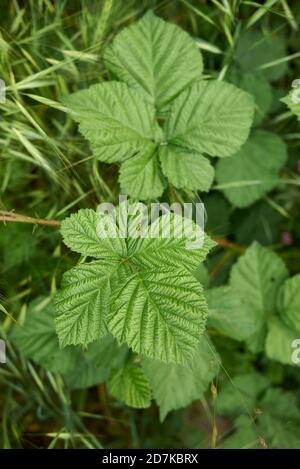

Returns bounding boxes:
[278,274,300,332]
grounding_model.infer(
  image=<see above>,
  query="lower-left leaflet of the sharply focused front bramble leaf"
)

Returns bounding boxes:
[54,260,129,347]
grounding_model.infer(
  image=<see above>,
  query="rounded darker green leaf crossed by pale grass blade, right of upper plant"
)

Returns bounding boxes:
[216,130,287,207]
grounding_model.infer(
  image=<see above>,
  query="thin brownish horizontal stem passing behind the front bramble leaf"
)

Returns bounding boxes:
[0,210,245,253]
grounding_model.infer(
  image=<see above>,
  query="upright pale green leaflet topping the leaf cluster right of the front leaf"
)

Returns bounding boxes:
[230,243,288,351]
